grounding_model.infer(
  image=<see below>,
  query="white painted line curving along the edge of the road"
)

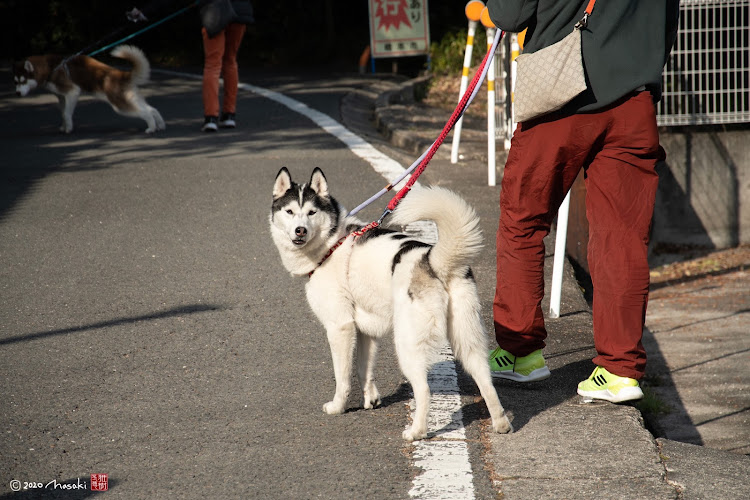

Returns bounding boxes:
[152,70,474,500]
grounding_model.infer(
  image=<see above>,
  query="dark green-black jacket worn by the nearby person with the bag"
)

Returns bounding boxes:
[487,0,679,112]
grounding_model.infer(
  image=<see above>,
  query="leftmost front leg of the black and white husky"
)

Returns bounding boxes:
[323,322,357,415]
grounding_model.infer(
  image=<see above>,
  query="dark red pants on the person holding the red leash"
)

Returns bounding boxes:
[493,92,664,379]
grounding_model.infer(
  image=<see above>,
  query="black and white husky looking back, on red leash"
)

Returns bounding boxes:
[270,168,512,441]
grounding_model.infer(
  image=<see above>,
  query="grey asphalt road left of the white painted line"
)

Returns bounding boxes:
[0,68,440,499]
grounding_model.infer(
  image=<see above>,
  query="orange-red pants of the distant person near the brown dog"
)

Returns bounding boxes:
[202,23,247,116]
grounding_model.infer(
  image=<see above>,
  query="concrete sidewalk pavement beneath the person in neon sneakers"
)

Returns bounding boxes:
[342,74,750,500]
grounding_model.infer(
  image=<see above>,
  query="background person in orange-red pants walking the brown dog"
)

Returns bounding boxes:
[199,0,255,132]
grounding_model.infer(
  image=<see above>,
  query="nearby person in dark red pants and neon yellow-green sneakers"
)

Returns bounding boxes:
[487,0,679,402]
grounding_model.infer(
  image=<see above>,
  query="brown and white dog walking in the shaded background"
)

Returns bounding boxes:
[13,45,166,134]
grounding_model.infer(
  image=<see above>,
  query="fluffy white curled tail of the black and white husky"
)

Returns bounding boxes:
[390,187,482,281]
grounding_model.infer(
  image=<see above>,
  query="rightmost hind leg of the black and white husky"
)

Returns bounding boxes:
[448,278,513,434]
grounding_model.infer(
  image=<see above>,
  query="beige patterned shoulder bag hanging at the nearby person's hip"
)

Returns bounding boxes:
[513,0,596,122]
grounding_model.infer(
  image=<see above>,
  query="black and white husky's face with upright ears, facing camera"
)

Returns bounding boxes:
[271,167,339,248]
